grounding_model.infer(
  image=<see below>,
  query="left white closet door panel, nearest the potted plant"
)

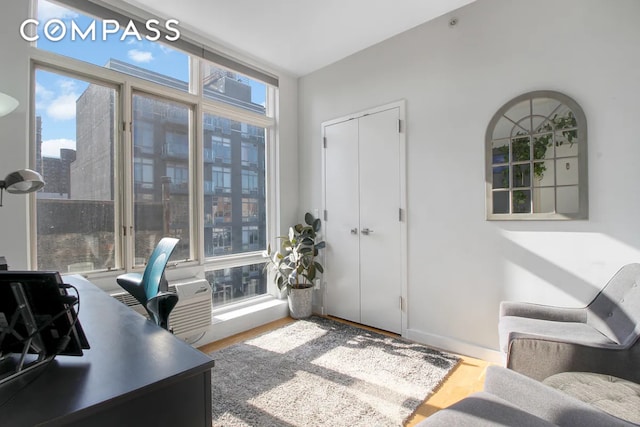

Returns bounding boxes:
[323,120,360,323]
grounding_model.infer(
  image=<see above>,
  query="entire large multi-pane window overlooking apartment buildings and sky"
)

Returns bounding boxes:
[32,0,277,305]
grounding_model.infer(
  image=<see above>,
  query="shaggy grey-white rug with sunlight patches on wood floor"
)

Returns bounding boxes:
[211,317,459,427]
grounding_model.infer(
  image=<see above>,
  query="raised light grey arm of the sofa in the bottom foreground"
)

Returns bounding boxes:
[484,366,633,427]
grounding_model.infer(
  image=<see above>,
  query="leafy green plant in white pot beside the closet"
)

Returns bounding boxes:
[264,212,325,319]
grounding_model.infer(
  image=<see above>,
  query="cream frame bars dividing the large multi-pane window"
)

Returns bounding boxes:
[29,15,278,293]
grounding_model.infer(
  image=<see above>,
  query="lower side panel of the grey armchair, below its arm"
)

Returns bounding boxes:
[506,337,640,383]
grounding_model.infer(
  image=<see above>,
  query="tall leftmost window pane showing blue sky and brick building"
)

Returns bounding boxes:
[34,69,121,272]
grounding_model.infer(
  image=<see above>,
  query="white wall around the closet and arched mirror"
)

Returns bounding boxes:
[299,0,640,358]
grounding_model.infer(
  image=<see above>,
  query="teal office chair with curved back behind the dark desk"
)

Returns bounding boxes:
[116,237,180,329]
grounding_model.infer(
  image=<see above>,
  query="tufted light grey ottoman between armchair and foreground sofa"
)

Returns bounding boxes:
[543,372,640,424]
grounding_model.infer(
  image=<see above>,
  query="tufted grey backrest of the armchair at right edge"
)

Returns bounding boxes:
[587,264,640,347]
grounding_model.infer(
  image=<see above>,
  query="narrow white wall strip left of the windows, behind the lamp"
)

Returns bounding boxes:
[0,1,29,270]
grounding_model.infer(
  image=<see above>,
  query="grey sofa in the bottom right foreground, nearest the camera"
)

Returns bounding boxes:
[418,366,638,427]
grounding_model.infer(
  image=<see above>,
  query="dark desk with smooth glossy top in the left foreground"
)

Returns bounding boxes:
[0,276,214,427]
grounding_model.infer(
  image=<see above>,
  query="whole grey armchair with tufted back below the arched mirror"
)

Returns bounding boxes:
[499,264,640,383]
